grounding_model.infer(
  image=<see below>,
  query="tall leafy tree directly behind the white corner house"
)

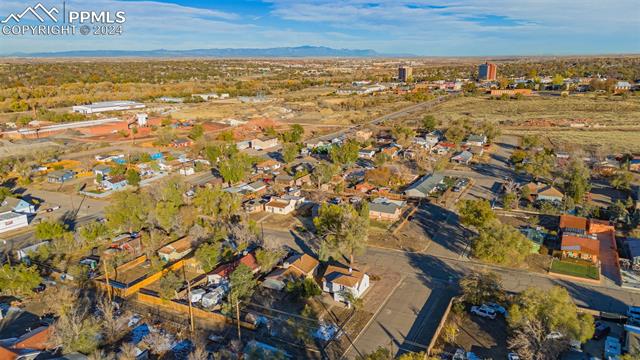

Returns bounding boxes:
[313,204,369,264]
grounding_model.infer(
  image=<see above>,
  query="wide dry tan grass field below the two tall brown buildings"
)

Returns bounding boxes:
[424,95,640,152]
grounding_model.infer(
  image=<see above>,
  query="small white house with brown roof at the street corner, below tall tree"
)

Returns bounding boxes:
[322,265,369,302]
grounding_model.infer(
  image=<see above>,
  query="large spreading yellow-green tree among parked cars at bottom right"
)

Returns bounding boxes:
[507,286,594,342]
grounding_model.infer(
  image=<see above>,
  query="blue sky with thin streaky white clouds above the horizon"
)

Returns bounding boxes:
[0,0,640,56]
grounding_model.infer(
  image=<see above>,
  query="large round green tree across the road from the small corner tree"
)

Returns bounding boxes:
[471,220,531,265]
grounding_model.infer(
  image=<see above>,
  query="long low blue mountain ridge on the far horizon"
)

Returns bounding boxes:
[5,46,398,58]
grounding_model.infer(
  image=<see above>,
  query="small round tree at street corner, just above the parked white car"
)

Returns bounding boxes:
[460,272,504,305]
